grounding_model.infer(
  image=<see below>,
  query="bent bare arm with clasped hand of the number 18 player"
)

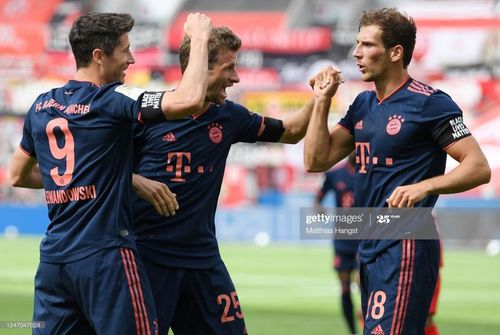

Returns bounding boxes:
[304,68,354,172]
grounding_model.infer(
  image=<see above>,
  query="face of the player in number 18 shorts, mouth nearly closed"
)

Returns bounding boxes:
[353,25,391,81]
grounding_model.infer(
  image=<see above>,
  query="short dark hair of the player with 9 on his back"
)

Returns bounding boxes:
[69,13,134,69]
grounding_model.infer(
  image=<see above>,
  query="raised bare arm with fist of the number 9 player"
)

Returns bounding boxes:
[161,13,212,120]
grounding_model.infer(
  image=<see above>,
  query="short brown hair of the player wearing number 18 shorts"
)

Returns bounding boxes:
[358,8,417,68]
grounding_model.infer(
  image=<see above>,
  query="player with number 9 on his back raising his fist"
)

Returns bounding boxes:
[10,13,211,335]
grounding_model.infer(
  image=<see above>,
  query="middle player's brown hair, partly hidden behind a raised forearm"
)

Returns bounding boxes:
[179,27,241,73]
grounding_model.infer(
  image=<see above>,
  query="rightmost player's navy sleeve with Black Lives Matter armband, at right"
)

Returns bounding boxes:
[422,91,471,149]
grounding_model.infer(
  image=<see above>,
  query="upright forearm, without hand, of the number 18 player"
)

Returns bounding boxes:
[304,97,331,172]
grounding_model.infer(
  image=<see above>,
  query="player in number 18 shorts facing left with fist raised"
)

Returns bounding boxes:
[304,8,491,335]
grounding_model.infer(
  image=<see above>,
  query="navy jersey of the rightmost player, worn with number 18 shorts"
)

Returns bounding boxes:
[339,78,470,261]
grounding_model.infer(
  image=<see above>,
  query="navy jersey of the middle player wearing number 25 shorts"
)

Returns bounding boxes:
[134,101,264,269]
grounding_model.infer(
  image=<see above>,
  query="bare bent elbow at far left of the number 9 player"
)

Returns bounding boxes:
[9,148,43,188]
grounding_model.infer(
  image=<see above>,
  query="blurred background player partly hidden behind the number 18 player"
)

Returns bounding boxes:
[314,152,359,334]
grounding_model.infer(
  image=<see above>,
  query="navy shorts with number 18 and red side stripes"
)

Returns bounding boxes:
[360,240,440,335]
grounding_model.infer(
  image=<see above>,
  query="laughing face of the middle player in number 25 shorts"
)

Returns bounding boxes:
[206,49,240,105]
